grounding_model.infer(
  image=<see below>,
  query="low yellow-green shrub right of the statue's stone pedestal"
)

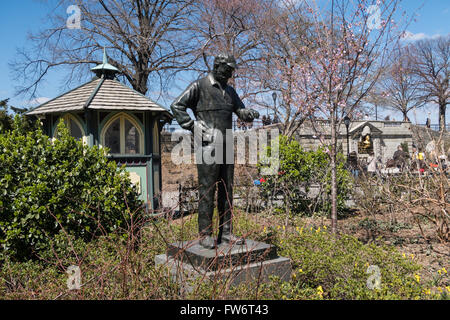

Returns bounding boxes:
[277,227,424,299]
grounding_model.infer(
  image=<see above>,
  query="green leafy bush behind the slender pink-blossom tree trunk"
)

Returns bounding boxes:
[260,136,352,215]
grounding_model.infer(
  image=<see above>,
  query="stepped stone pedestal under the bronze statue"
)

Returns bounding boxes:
[155,239,291,291]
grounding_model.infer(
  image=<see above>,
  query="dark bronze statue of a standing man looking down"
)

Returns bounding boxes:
[171,54,259,249]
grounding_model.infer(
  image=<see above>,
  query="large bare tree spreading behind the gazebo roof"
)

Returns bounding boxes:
[10,0,195,96]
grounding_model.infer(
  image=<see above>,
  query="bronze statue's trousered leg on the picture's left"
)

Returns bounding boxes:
[197,164,219,248]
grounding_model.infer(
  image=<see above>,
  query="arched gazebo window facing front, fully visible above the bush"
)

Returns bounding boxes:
[101,113,144,154]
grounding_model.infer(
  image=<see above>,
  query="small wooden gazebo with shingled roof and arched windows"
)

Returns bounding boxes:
[27,51,173,210]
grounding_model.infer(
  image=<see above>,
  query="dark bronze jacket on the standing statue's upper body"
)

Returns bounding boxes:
[171,74,245,136]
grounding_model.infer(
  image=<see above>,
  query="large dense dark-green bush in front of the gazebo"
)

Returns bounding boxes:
[0,117,142,260]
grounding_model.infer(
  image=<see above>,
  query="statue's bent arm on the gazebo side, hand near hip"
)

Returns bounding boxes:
[170,81,199,130]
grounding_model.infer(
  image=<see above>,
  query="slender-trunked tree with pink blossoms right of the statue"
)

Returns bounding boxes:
[256,0,408,232]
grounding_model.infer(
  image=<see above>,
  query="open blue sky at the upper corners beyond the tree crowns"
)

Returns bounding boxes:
[0,0,450,123]
